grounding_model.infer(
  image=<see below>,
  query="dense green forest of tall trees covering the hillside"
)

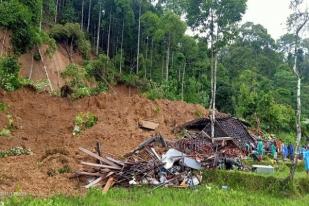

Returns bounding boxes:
[0,0,309,142]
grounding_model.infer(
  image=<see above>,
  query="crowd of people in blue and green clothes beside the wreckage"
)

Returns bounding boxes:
[245,138,309,175]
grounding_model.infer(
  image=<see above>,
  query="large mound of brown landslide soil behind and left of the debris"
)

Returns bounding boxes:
[0,86,207,196]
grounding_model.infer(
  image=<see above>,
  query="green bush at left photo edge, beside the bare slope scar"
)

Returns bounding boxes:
[0,57,20,91]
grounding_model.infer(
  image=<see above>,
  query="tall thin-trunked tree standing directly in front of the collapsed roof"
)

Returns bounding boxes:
[187,0,247,138]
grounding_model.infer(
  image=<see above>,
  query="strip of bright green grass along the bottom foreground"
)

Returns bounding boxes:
[0,185,309,206]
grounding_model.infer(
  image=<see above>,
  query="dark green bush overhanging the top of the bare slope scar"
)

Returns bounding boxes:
[49,23,90,59]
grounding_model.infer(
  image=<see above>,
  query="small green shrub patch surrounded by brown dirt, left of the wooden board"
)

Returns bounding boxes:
[73,112,98,135]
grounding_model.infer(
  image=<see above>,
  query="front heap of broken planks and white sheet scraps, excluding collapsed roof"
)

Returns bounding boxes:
[77,135,203,191]
